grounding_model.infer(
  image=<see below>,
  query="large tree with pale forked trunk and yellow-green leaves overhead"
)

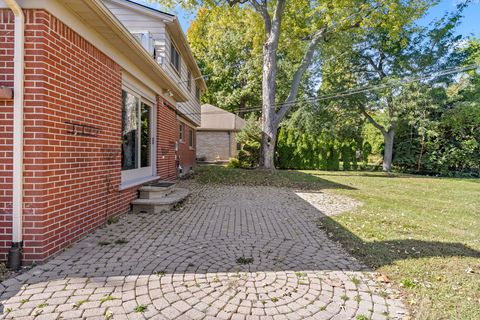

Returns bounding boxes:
[160,0,433,169]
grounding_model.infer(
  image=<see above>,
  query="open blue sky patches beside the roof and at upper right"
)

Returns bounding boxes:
[133,0,480,37]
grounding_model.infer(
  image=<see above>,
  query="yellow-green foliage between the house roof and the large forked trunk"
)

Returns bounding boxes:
[187,6,263,111]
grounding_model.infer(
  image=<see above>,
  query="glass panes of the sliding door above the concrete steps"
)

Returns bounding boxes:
[121,90,154,185]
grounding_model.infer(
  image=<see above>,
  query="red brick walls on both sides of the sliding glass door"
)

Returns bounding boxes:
[0,10,178,263]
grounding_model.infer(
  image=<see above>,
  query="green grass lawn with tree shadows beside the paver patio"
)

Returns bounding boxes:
[197,166,480,319]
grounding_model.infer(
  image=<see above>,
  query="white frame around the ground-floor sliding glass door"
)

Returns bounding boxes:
[120,86,158,189]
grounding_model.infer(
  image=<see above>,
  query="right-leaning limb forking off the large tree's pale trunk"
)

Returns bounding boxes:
[275,25,327,125]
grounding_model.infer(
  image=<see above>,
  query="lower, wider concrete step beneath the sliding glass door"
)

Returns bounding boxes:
[132,188,190,214]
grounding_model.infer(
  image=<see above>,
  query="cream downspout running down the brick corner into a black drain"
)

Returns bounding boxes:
[4,0,25,270]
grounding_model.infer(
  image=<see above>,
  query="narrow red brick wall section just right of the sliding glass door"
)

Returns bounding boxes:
[157,97,178,180]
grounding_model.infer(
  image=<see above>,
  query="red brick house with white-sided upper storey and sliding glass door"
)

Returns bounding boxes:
[0,0,206,264]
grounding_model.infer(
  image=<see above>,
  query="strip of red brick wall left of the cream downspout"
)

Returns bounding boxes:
[0,10,14,260]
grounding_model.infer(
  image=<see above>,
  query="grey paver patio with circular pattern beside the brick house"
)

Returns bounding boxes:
[0,183,405,320]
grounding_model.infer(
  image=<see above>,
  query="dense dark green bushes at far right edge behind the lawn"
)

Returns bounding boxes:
[394,39,480,177]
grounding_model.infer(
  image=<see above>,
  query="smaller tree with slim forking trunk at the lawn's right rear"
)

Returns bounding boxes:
[314,6,460,171]
